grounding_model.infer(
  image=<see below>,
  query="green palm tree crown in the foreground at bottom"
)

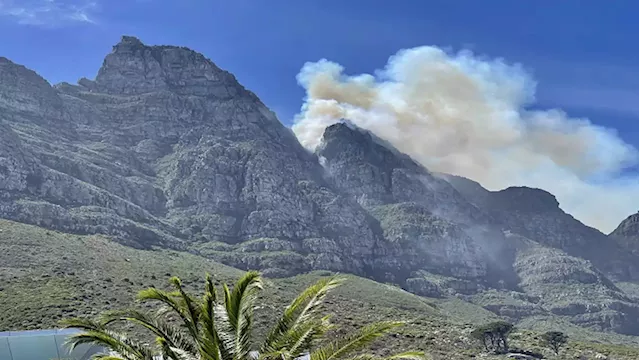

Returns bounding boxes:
[63,271,424,360]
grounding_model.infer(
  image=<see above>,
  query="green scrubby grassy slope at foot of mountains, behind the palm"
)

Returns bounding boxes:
[0,220,640,359]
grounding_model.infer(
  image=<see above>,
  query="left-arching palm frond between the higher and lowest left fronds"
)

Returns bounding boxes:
[103,310,198,355]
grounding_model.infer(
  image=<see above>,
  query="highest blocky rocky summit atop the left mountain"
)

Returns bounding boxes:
[95,36,250,99]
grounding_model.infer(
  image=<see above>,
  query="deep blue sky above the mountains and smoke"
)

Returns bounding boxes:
[0,0,640,230]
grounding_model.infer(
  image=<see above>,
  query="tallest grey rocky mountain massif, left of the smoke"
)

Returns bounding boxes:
[0,37,378,274]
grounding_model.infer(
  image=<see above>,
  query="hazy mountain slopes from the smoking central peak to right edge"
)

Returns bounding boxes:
[317,123,640,334]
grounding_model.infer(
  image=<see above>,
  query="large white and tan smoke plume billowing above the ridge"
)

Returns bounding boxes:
[293,47,640,232]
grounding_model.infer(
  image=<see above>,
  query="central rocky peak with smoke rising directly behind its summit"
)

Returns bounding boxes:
[316,122,513,287]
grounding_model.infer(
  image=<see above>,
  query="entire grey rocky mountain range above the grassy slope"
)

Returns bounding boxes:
[0,36,640,335]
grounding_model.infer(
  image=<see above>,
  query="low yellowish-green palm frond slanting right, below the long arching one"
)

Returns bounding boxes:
[311,321,404,360]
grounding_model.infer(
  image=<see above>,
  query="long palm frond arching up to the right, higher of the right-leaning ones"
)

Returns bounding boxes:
[260,277,344,352]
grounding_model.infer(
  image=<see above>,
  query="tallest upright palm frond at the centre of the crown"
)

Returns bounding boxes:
[223,271,262,360]
